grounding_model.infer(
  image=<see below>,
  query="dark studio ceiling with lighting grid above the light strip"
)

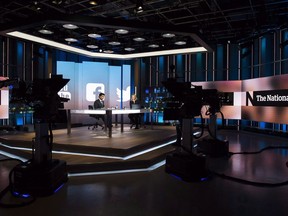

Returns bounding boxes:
[0,0,288,54]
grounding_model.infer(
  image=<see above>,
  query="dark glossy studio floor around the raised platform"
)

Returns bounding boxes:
[0,131,288,216]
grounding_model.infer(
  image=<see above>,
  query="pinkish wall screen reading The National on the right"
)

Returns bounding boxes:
[192,75,288,124]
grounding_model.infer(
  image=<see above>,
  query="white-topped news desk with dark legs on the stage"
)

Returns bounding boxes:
[67,109,153,137]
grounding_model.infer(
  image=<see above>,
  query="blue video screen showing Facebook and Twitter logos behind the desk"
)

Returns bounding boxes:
[57,61,131,109]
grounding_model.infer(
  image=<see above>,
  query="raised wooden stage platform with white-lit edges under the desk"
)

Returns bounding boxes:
[0,125,176,174]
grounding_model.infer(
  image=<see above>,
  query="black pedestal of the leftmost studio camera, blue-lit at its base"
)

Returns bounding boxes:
[13,123,68,196]
